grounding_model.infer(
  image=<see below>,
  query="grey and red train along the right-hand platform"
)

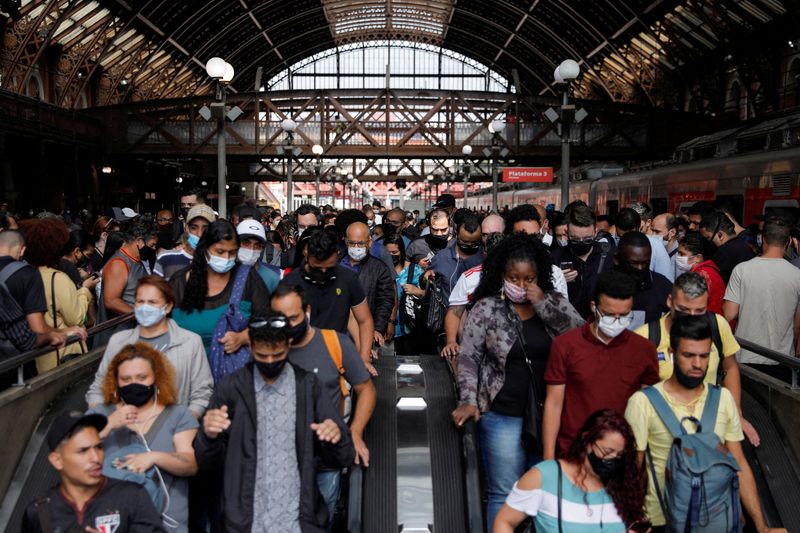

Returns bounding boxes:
[467,146,800,225]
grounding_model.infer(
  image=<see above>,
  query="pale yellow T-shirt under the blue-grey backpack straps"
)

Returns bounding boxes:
[625,382,744,526]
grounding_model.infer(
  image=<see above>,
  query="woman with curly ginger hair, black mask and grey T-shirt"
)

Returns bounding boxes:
[89,342,199,532]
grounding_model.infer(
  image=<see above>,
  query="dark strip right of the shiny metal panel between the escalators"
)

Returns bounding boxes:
[420,355,467,532]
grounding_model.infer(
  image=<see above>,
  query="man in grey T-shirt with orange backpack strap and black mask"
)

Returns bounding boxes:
[271,285,376,518]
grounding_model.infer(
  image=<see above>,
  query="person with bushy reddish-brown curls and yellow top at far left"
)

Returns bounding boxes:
[20,218,97,373]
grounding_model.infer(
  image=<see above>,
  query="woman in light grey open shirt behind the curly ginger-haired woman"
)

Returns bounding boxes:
[86,276,214,418]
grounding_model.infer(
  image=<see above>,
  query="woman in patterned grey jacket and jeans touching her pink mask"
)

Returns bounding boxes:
[453,233,583,525]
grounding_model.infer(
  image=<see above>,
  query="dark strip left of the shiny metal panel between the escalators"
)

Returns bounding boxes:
[362,357,397,533]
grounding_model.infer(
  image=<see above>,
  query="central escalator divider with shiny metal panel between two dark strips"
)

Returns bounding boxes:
[348,355,483,533]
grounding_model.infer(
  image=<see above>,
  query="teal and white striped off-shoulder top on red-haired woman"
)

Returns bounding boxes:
[506,460,626,533]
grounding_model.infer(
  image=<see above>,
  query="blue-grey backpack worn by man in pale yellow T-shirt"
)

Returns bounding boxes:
[642,385,744,533]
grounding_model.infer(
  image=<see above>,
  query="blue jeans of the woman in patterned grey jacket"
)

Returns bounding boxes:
[478,411,536,533]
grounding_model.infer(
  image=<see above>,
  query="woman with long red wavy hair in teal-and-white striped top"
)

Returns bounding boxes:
[494,409,648,533]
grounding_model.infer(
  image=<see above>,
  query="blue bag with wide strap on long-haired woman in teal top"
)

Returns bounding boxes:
[208,265,250,383]
